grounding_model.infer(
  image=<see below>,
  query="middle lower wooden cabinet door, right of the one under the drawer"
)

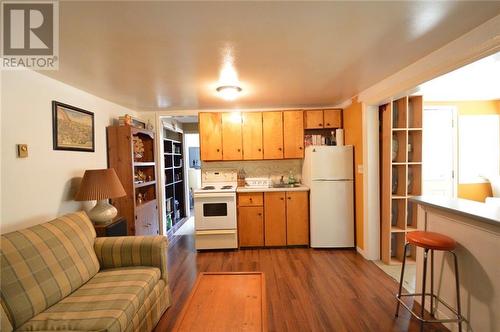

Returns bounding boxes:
[264,192,286,246]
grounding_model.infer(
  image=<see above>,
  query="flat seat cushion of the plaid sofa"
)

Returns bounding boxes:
[19,266,165,331]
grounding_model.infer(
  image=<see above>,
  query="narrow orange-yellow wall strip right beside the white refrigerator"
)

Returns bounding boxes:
[344,101,364,249]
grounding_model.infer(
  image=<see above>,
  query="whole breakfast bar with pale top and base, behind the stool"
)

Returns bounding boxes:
[409,196,500,331]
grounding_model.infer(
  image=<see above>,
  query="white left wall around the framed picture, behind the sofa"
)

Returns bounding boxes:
[0,70,136,233]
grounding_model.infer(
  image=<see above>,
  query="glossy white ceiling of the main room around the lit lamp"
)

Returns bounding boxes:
[43,1,500,111]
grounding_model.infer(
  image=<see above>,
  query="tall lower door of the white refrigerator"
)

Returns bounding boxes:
[310,181,354,248]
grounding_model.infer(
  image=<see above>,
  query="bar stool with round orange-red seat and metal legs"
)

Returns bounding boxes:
[396,231,464,331]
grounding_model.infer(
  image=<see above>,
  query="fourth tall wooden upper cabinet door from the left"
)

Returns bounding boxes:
[262,112,283,159]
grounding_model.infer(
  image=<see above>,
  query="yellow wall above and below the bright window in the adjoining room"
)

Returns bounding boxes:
[424,100,500,202]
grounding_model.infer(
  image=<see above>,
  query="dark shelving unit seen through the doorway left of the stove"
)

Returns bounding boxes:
[163,128,186,231]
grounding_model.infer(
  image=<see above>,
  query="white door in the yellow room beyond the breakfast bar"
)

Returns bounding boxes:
[422,106,457,198]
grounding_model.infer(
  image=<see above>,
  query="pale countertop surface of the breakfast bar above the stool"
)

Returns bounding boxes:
[410,196,500,226]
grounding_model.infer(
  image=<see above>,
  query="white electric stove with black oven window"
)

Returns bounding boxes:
[193,169,238,250]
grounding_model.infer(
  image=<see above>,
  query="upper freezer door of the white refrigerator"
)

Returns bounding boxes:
[309,146,353,181]
